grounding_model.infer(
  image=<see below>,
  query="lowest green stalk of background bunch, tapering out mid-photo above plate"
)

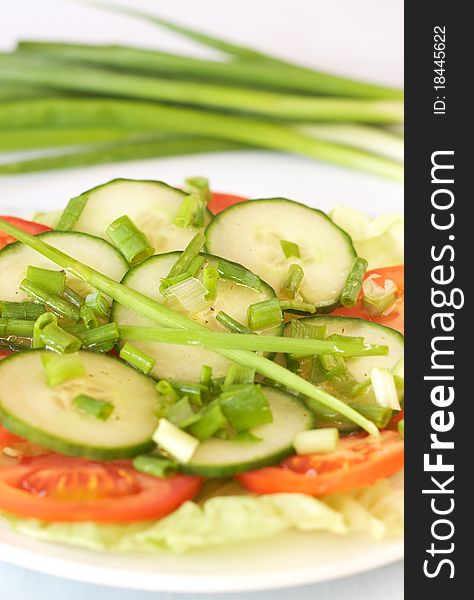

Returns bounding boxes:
[0,135,247,175]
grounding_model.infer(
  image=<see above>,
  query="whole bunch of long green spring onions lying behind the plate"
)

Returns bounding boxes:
[0,4,403,179]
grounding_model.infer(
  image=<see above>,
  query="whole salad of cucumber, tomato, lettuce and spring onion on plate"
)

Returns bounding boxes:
[0,177,404,552]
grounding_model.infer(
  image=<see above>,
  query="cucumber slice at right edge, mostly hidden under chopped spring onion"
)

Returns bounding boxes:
[285,315,404,382]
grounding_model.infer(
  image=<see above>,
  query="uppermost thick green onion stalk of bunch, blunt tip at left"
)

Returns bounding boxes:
[17,40,403,100]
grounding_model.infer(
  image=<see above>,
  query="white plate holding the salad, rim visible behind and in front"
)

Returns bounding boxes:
[0,152,403,593]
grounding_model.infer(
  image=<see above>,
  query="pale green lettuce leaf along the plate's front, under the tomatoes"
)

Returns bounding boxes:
[4,480,403,553]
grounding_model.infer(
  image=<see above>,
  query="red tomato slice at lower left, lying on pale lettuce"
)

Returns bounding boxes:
[0,454,201,523]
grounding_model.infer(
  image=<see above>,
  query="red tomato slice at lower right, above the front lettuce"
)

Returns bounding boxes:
[238,431,404,496]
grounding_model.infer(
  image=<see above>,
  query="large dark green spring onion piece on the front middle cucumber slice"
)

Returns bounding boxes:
[218,384,273,431]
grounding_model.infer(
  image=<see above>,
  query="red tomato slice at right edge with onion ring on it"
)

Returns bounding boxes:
[332,265,405,333]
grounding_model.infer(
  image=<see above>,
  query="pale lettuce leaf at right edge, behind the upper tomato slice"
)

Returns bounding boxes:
[330,206,404,269]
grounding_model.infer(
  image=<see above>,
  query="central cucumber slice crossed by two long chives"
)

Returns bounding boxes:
[112,252,282,381]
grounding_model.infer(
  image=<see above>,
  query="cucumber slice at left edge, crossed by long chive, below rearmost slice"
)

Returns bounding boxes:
[0,231,129,302]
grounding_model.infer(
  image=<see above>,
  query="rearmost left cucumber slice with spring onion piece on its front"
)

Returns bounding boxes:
[67,179,210,253]
